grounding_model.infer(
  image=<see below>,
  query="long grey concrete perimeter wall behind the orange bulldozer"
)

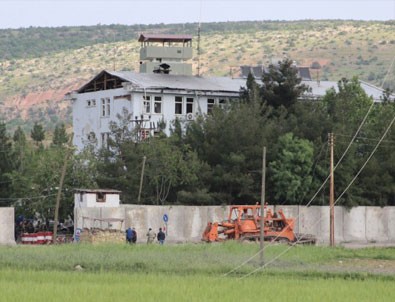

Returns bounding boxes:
[74,205,395,244]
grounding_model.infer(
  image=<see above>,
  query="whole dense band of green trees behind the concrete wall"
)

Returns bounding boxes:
[0,60,395,224]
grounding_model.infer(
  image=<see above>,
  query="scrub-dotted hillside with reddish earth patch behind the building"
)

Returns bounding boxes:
[0,21,395,130]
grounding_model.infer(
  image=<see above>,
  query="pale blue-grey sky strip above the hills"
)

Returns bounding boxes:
[0,0,395,28]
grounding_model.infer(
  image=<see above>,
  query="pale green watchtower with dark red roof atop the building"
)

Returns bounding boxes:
[138,34,192,75]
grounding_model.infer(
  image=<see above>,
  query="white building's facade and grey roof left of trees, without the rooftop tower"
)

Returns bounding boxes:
[69,70,245,150]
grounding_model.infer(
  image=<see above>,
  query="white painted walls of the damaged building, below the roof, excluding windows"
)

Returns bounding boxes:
[73,88,237,151]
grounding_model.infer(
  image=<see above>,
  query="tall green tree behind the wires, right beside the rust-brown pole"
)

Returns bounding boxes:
[323,77,377,206]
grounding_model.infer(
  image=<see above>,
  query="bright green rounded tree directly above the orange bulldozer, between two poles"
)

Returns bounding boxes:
[269,133,314,204]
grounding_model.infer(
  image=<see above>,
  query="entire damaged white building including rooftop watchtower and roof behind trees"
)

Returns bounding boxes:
[68,35,390,150]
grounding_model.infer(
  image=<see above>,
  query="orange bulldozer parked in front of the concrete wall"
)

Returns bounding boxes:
[202,204,316,244]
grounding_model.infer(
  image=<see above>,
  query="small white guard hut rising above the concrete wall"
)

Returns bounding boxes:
[74,189,121,208]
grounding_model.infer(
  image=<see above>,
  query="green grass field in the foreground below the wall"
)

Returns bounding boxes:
[0,242,395,302]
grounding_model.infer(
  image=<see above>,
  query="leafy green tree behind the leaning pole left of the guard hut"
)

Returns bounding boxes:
[9,134,97,219]
